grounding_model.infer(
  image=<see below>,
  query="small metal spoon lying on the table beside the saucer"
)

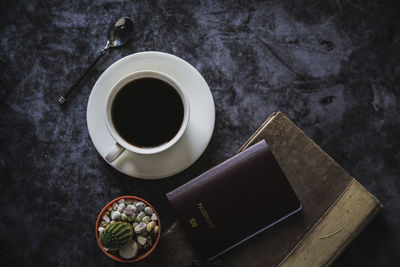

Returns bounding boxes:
[58,17,133,104]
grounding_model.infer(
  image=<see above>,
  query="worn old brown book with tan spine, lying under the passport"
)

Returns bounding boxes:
[140,112,381,266]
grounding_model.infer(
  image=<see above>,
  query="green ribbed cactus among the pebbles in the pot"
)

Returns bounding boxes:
[100,222,133,250]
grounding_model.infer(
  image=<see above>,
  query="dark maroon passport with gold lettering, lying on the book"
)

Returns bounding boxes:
[167,140,301,259]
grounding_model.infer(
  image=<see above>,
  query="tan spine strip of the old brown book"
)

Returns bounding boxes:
[278,178,382,267]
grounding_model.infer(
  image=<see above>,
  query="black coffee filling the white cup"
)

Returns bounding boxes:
[111,78,183,147]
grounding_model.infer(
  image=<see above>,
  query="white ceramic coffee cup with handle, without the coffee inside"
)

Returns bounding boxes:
[104,70,190,163]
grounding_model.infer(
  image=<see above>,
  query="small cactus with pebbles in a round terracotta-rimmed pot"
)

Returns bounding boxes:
[96,196,161,262]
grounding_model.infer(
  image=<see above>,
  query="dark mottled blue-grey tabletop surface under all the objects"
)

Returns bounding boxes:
[0,0,400,266]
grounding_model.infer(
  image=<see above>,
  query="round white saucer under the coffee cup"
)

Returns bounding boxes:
[87,52,215,179]
